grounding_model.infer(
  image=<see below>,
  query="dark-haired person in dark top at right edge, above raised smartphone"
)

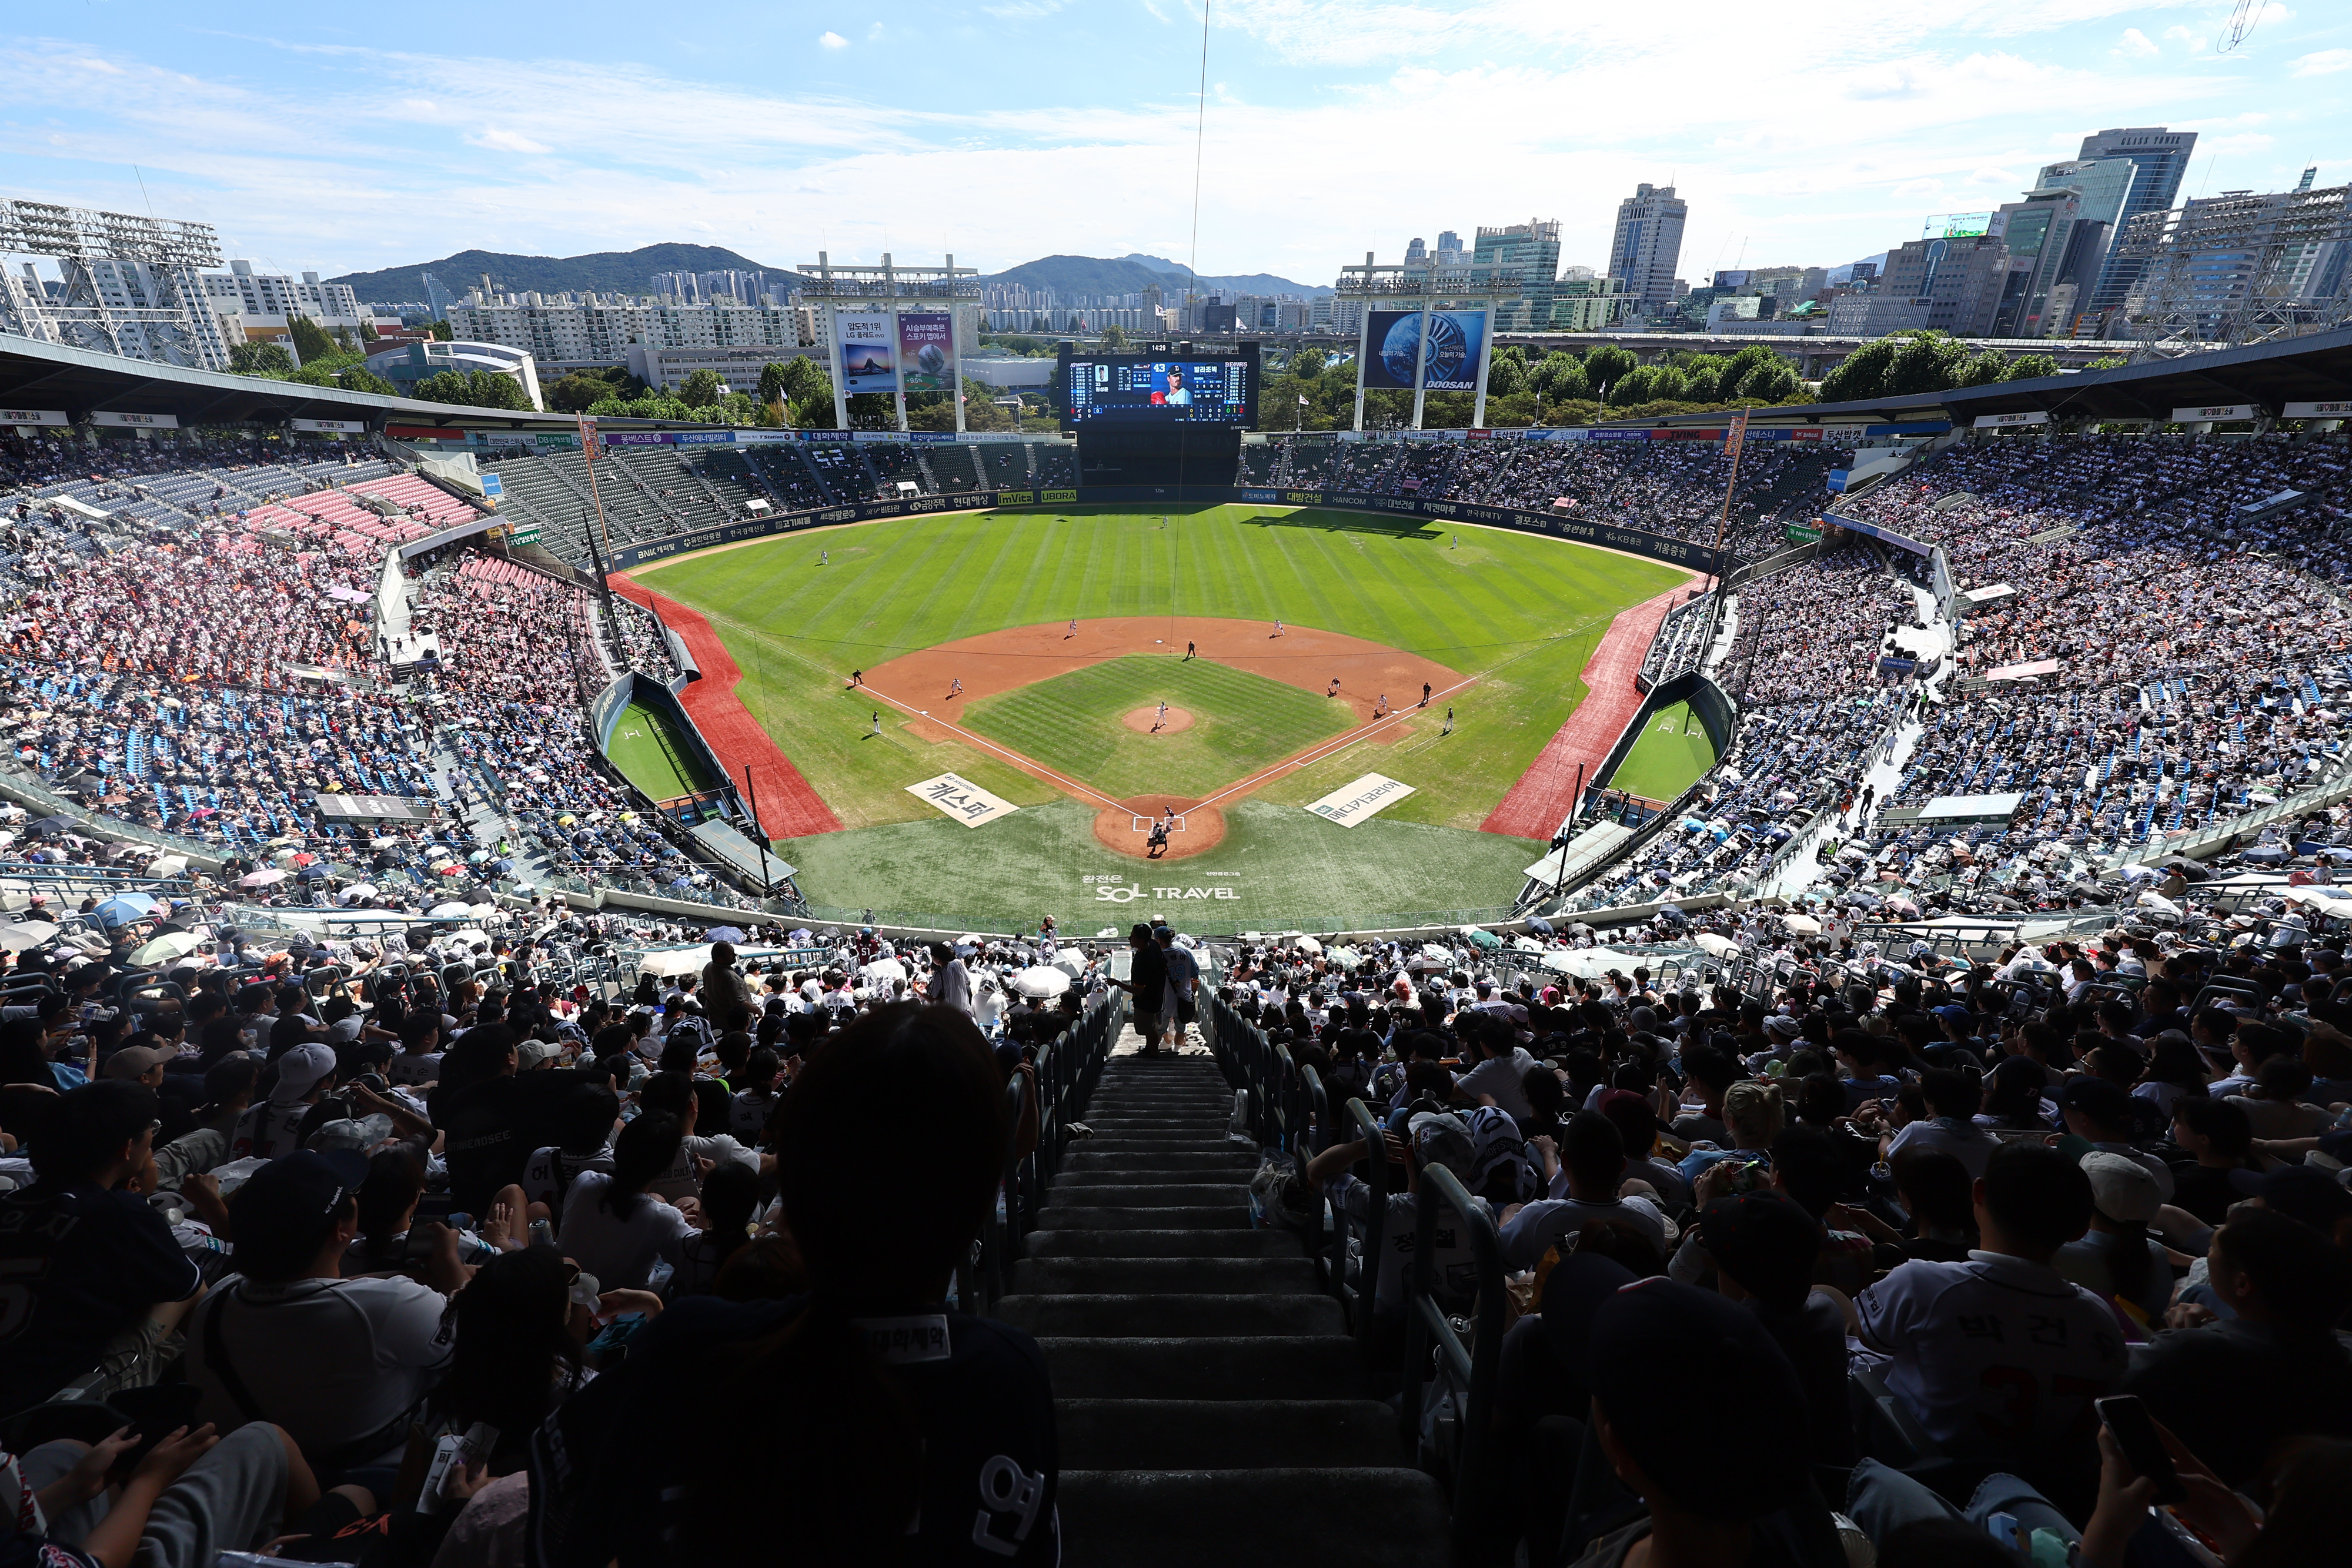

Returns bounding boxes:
[2124,1206,2352,1486]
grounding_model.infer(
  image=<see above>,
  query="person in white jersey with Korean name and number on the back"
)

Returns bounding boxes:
[1853,1142,2126,1465]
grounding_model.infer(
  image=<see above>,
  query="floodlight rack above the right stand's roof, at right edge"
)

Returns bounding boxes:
[2110,186,2352,360]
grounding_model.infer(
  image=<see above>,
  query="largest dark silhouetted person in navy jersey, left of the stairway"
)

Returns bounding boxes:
[532,1004,1061,1568]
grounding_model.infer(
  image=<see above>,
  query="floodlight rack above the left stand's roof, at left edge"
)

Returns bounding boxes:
[0,200,228,369]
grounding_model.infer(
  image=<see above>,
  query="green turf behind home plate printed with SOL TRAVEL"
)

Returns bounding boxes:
[776,799,1543,935]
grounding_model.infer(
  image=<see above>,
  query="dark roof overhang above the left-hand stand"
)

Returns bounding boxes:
[0,336,701,430]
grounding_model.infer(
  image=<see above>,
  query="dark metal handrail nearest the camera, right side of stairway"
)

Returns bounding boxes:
[1367,1166,1503,1542]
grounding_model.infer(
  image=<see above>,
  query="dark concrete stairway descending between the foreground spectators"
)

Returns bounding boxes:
[997,1034,1446,1568]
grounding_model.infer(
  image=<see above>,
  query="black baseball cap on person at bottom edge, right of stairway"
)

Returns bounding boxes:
[1583,1279,1811,1523]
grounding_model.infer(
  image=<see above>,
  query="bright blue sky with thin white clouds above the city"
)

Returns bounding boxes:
[0,0,2352,282]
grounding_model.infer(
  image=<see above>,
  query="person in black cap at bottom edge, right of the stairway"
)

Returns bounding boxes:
[1576,1279,1842,1568]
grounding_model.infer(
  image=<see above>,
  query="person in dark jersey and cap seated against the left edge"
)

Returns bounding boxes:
[0,1079,205,1415]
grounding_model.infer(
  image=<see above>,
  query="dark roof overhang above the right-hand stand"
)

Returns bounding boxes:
[1644,327,2352,426]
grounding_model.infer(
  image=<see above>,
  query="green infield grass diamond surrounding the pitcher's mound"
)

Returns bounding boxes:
[964,658,1355,799]
